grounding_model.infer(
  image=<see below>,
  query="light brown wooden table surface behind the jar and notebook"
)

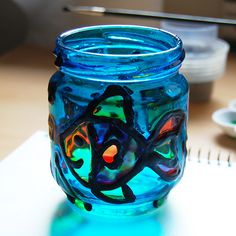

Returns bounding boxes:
[0,45,236,160]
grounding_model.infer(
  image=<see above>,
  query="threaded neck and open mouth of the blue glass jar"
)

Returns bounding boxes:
[54,25,184,82]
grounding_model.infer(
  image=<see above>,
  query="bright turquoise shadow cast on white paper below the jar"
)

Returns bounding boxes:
[49,200,175,236]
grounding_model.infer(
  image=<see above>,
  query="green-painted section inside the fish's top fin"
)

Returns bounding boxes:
[94,95,126,122]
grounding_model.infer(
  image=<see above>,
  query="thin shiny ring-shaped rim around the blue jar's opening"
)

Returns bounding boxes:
[57,24,183,58]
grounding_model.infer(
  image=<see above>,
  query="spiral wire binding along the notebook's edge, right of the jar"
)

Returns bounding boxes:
[187,146,236,167]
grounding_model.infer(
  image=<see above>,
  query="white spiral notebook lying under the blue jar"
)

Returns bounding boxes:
[0,131,236,236]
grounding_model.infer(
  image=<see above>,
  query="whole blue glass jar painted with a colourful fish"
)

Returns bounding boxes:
[48,25,188,217]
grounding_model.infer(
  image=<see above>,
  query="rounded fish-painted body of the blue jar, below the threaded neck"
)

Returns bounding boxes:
[49,25,188,217]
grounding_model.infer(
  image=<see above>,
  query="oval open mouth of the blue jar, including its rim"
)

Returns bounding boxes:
[57,25,183,59]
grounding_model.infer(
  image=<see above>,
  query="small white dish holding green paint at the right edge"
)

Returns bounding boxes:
[212,108,236,138]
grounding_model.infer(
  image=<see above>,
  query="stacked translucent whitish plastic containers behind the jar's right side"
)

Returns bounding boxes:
[161,20,229,84]
